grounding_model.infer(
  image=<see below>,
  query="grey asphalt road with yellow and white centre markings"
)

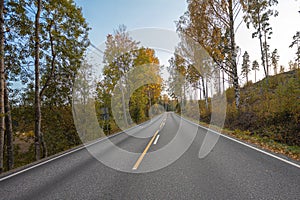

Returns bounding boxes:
[0,113,300,200]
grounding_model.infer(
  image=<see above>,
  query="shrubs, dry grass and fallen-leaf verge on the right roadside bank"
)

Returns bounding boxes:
[182,70,300,160]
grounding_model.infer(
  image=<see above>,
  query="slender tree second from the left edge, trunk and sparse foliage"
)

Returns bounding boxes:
[4,0,32,170]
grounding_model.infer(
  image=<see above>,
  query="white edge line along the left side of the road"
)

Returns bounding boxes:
[0,114,165,182]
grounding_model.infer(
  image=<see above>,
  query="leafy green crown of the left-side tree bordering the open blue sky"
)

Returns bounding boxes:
[40,0,90,106]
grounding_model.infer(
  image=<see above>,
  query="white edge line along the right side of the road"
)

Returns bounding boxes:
[178,115,300,169]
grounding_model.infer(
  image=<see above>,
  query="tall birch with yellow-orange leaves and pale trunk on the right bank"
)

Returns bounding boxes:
[177,0,241,108]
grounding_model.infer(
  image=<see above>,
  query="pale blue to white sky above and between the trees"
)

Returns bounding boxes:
[75,0,300,84]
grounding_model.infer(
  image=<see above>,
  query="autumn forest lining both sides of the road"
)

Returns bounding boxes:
[0,0,300,173]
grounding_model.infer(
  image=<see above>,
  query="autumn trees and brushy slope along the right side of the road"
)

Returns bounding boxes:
[168,0,300,145]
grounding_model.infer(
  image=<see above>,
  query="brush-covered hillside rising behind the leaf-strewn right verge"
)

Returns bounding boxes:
[226,70,300,146]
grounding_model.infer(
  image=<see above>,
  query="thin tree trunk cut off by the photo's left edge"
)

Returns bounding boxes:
[0,0,5,173]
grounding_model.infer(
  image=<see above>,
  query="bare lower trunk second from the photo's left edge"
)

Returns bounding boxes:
[4,83,14,170]
